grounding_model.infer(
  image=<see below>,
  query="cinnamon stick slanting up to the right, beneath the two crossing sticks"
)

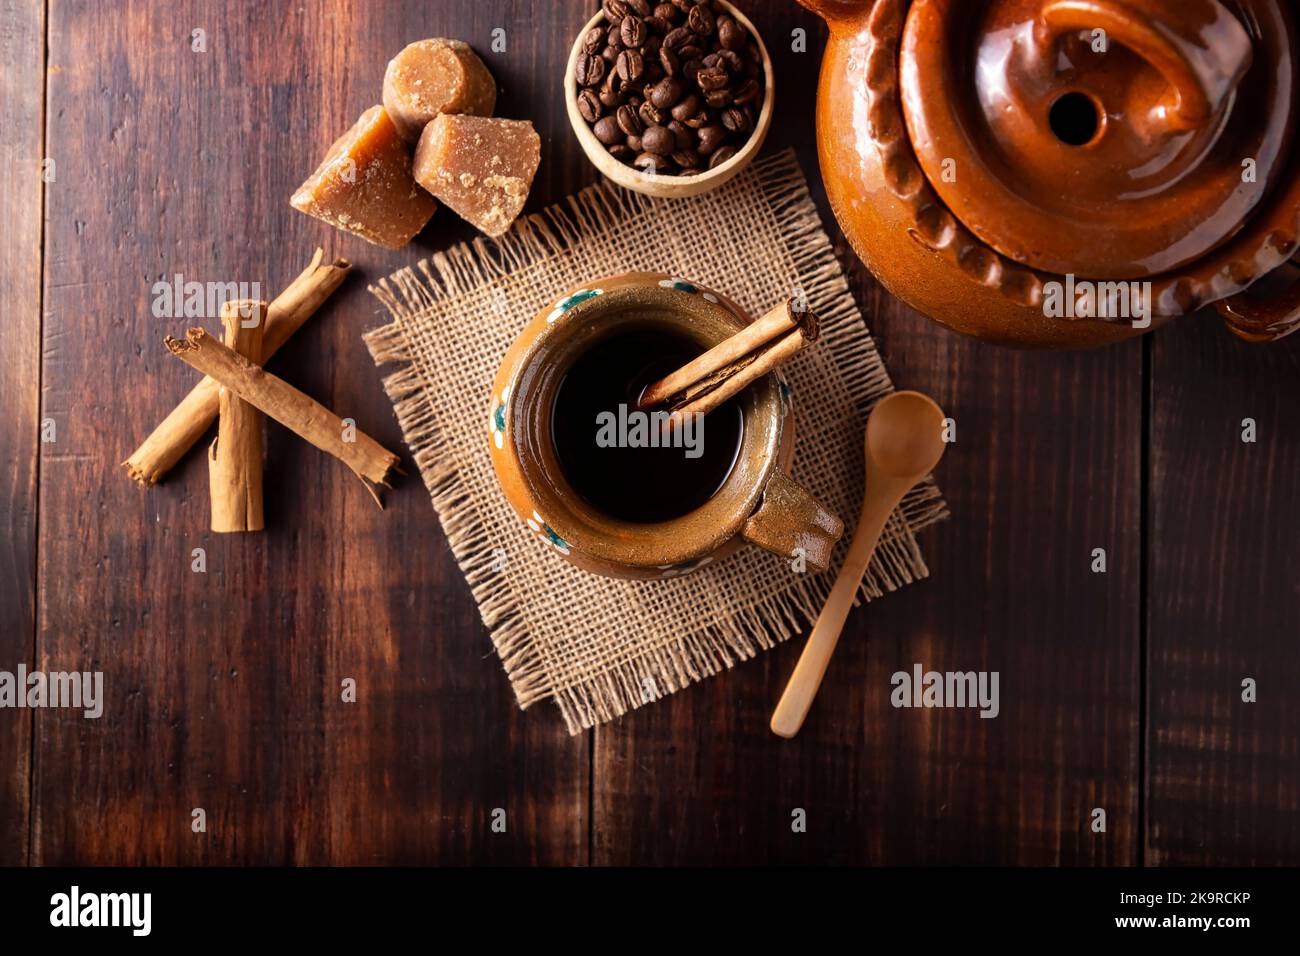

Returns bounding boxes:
[122,248,352,486]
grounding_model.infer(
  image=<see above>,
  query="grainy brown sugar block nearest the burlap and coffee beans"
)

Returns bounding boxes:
[415,113,542,237]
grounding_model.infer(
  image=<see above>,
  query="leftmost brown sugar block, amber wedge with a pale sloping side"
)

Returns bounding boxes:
[289,107,438,248]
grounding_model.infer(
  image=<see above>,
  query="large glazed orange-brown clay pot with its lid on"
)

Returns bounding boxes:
[800,0,1300,347]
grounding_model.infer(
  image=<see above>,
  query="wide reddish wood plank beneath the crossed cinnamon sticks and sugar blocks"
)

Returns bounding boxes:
[34,0,589,864]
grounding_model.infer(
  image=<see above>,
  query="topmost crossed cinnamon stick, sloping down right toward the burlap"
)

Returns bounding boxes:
[164,329,399,507]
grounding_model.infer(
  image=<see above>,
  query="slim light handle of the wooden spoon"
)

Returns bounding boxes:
[771,483,911,737]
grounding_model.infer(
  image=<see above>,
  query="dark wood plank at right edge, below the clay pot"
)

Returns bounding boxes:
[1147,313,1300,866]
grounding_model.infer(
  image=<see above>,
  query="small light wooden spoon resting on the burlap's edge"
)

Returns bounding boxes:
[771,392,946,737]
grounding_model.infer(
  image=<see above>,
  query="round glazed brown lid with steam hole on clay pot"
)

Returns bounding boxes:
[898,0,1297,280]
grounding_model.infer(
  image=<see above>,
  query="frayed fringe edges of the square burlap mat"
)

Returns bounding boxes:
[364,150,948,734]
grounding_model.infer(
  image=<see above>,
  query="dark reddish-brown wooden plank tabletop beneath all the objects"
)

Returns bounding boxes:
[0,0,1300,865]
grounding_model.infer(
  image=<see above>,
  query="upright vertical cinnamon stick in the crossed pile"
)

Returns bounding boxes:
[208,299,267,533]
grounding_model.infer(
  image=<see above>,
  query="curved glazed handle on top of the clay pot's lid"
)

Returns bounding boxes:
[1037,0,1251,130]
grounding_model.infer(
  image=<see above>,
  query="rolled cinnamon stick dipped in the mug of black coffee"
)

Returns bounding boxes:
[638,299,820,415]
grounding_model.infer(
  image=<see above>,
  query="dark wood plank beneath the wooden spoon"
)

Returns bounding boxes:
[593,0,1141,865]
